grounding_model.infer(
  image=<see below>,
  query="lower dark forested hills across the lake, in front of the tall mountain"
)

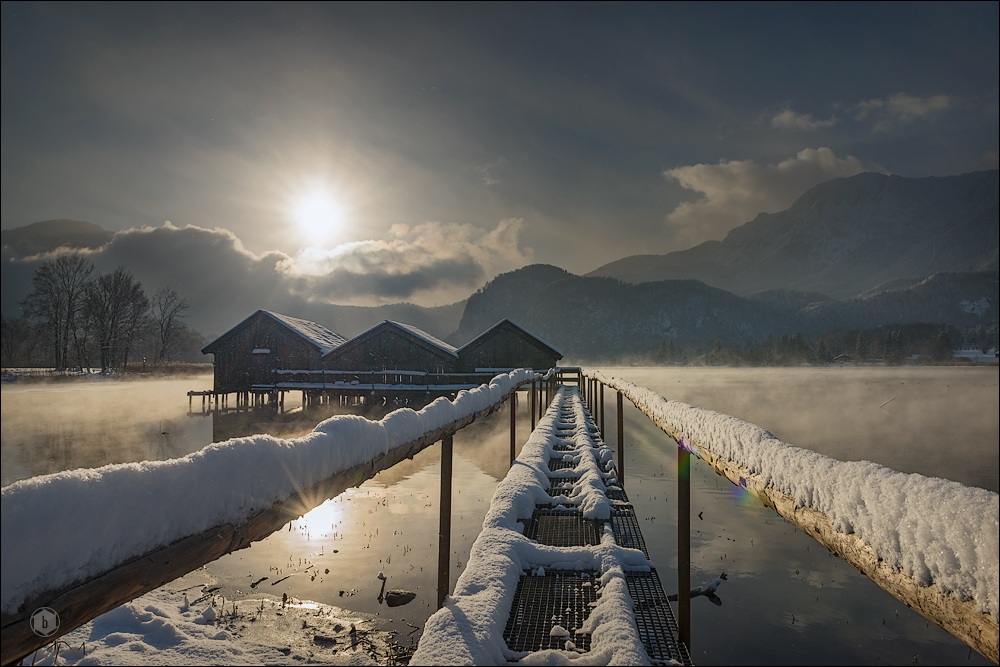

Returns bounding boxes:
[456,265,1000,360]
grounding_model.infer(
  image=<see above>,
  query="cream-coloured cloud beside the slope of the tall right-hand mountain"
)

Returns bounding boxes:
[663,148,865,247]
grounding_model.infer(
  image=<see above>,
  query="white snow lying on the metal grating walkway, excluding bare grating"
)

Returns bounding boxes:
[411,387,651,665]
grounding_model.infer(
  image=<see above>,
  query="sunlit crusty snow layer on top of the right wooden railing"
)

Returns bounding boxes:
[592,373,1000,619]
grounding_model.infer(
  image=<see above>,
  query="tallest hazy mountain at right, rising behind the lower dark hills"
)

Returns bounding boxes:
[587,170,1000,298]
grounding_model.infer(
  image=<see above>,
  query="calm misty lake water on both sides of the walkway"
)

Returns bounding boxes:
[2,368,1000,665]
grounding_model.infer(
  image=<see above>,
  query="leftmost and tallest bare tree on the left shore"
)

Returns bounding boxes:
[21,253,94,368]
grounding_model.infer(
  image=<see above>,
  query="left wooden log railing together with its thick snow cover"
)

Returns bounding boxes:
[0,370,551,664]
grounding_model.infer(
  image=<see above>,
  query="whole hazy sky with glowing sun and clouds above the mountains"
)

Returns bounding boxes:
[0,2,1000,314]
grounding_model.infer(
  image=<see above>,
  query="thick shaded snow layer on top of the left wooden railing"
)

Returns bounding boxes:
[0,370,537,614]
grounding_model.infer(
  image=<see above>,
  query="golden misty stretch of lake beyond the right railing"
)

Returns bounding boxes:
[605,366,1000,492]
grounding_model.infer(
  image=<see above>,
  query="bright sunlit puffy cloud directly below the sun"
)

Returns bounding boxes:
[277,218,531,303]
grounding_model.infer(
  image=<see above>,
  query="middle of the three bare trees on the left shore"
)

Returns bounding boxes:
[85,266,149,370]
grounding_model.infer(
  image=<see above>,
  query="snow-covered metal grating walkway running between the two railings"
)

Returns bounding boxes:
[414,386,691,664]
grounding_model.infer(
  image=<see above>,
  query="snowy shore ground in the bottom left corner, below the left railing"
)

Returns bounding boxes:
[18,570,395,665]
